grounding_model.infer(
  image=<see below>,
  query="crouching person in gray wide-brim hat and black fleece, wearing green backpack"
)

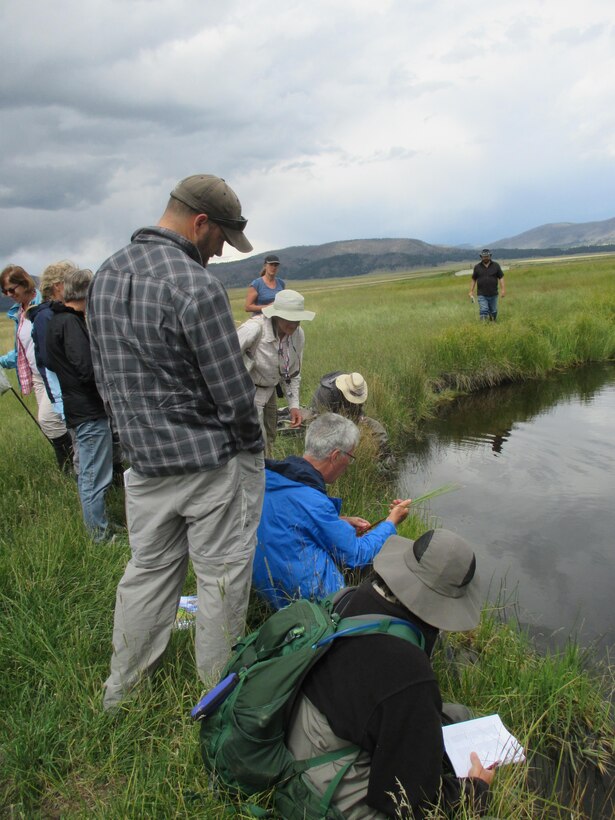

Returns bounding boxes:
[287,530,494,818]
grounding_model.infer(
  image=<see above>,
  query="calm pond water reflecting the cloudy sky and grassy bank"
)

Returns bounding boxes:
[399,365,615,647]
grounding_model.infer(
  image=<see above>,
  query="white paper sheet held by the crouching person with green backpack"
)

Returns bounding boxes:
[442,715,525,777]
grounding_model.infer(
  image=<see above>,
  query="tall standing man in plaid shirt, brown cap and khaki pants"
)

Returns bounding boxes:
[88,174,264,709]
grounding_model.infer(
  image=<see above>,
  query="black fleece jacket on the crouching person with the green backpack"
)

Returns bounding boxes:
[302,580,488,818]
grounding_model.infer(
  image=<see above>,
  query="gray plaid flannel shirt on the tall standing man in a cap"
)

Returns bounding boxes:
[87,227,264,476]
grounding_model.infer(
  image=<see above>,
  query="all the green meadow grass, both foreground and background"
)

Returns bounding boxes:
[0,256,615,818]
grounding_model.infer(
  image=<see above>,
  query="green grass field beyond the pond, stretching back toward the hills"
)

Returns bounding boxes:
[231,257,615,442]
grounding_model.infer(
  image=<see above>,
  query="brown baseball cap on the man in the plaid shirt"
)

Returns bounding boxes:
[171,174,253,253]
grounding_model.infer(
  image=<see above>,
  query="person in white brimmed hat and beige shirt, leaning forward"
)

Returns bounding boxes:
[237,290,316,456]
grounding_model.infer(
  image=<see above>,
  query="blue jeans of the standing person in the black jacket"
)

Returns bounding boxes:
[75,418,113,541]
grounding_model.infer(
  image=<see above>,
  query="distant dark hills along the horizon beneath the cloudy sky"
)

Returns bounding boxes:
[208,218,615,287]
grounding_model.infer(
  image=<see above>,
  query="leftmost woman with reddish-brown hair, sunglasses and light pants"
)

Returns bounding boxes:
[0,265,71,471]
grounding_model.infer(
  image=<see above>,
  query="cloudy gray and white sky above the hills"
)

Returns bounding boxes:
[0,0,615,274]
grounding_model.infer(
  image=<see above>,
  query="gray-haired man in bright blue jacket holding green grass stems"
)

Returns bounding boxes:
[253,413,410,609]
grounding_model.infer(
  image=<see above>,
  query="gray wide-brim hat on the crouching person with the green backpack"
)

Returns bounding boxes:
[374,529,482,632]
